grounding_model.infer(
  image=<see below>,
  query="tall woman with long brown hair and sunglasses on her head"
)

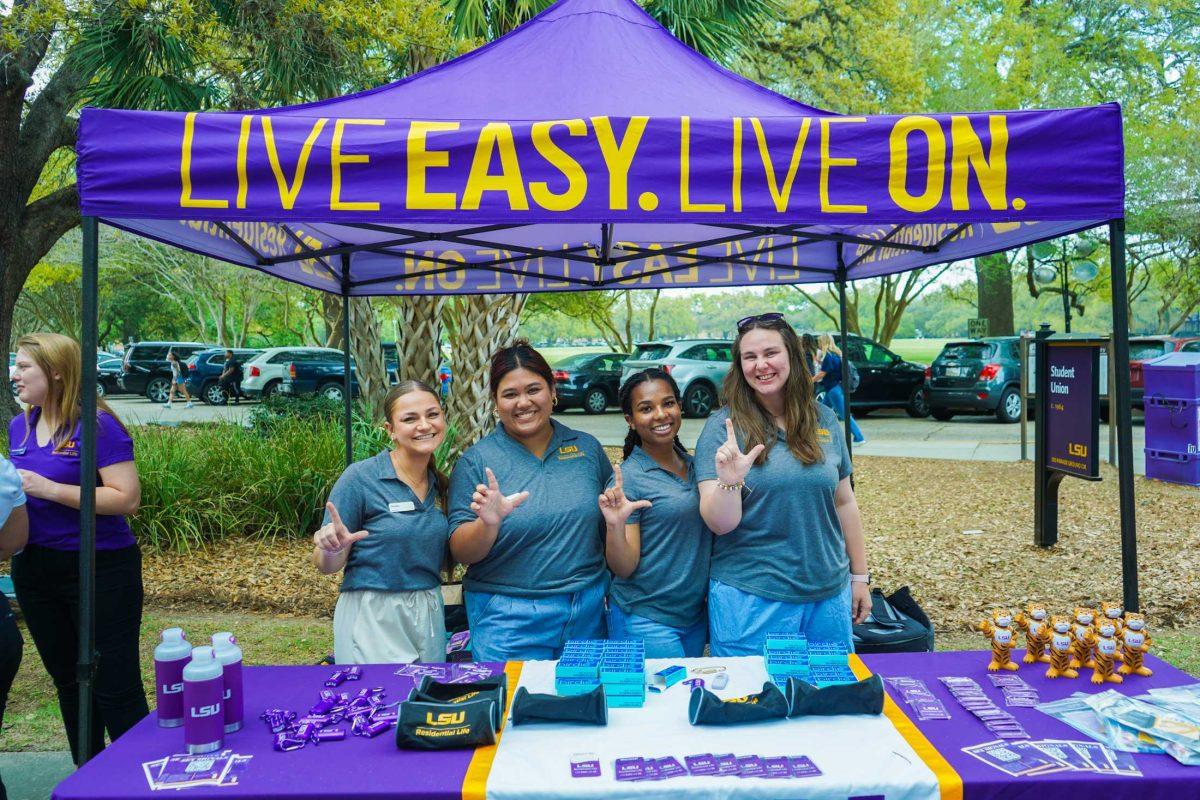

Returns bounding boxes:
[696,313,871,656]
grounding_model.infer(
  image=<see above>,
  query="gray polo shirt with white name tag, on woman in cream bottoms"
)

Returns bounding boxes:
[325,450,449,591]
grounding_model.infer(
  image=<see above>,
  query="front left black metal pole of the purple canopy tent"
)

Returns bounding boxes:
[74,217,100,764]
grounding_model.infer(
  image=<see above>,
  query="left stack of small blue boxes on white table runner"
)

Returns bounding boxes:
[554,639,646,709]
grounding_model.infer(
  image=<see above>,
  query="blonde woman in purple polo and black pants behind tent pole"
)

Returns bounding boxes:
[8,333,149,763]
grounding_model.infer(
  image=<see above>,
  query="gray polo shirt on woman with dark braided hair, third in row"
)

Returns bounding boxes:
[608,447,713,627]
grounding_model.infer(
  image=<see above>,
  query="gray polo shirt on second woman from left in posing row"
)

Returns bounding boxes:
[449,420,612,597]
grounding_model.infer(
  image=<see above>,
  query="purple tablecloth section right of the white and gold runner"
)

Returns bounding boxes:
[862,650,1200,800]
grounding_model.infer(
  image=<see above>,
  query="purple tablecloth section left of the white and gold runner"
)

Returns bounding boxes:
[53,664,500,800]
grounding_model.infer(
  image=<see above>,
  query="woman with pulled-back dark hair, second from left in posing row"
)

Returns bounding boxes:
[450,341,612,661]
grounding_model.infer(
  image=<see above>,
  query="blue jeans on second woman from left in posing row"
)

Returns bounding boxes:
[463,578,608,661]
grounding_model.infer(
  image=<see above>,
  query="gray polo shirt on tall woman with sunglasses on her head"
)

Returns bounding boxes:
[696,404,852,603]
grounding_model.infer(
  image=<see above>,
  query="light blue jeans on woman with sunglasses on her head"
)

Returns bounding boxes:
[708,578,854,657]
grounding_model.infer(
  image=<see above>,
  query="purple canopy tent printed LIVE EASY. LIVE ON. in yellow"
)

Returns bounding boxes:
[78,0,1138,762]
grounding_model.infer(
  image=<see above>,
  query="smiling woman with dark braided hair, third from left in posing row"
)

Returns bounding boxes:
[600,368,713,658]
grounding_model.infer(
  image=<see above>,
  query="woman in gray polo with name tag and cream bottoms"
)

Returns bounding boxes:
[312,380,449,664]
